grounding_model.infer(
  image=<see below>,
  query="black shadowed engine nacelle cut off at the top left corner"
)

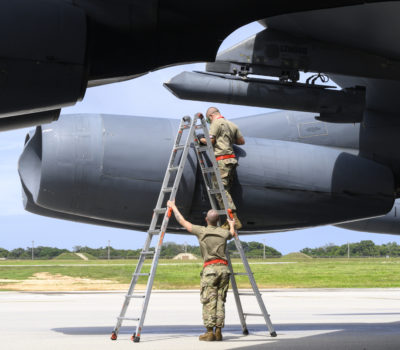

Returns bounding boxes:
[0,0,87,119]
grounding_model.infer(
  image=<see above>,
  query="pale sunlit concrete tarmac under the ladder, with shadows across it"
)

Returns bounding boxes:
[0,289,400,350]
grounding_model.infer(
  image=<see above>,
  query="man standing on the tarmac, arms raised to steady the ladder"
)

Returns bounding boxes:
[167,201,235,341]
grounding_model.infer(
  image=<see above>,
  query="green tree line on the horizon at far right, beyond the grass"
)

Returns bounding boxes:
[301,240,400,258]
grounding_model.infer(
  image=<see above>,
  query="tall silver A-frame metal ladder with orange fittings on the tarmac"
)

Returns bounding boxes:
[111,114,276,343]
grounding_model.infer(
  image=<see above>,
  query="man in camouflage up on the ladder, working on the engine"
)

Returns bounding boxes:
[198,107,245,230]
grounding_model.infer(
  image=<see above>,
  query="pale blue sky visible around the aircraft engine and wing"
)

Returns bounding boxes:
[0,23,400,254]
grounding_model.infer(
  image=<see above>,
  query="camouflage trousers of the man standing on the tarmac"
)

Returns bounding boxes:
[200,264,229,328]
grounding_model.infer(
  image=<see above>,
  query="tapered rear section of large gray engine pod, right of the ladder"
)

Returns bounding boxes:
[233,138,394,231]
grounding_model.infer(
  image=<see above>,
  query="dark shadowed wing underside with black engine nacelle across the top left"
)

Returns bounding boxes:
[0,0,386,130]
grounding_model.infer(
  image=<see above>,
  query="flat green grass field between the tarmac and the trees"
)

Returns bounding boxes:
[0,258,400,290]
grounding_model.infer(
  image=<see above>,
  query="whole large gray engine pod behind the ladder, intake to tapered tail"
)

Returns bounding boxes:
[19,115,394,233]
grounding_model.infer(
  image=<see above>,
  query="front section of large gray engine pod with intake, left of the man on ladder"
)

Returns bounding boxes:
[19,115,197,226]
